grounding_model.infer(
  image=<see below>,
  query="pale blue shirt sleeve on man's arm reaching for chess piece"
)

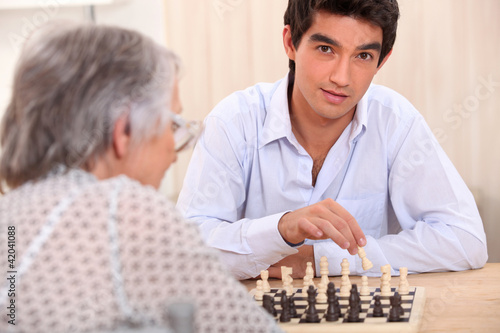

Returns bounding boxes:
[177,116,297,279]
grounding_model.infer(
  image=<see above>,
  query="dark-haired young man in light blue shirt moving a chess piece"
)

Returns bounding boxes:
[178,0,487,278]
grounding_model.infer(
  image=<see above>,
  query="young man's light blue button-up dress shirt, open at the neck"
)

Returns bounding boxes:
[177,76,487,279]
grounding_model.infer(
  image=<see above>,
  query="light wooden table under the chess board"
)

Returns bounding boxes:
[241,263,500,332]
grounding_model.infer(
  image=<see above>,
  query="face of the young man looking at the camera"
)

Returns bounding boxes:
[283,12,387,122]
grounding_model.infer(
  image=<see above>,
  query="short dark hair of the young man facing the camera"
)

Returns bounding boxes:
[284,0,399,74]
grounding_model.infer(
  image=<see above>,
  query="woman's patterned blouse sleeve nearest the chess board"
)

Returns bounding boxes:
[118,180,280,332]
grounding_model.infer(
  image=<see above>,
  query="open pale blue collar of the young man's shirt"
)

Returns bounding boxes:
[259,74,368,148]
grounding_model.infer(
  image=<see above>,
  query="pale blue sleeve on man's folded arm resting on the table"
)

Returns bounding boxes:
[314,117,488,276]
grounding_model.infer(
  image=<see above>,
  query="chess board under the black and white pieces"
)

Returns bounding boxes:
[250,287,425,333]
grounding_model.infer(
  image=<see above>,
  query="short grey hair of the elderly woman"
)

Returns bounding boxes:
[0,23,180,191]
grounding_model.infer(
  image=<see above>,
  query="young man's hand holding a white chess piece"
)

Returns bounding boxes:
[278,199,366,255]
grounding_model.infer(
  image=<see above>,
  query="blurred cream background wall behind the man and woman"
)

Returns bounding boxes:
[0,0,500,262]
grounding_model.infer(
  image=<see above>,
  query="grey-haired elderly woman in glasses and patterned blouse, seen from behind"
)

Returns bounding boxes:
[0,24,278,333]
